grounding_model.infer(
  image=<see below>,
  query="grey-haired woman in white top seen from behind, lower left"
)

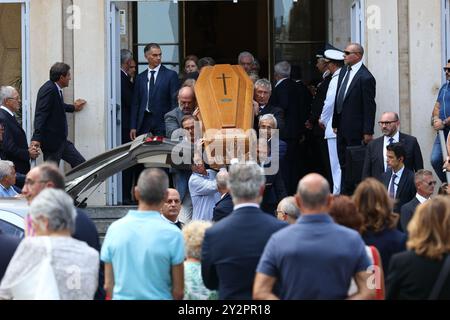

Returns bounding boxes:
[0,188,99,300]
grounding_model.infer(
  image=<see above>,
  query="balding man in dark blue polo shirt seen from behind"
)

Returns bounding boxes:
[253,173,375,300]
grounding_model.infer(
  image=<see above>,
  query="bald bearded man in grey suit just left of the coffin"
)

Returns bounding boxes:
[164,87,197,140]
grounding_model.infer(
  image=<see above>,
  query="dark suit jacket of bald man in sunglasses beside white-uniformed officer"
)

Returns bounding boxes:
[332,64,377,141]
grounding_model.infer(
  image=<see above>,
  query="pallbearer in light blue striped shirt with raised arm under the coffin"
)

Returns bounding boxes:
[189,162,220,221]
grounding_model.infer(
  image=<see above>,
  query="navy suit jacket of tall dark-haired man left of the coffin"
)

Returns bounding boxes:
[130,65,179,134]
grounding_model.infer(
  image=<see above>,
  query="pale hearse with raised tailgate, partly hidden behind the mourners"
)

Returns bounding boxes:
[0,135,193,238]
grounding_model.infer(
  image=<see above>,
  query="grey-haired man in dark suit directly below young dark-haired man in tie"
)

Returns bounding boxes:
[400,169,436,233]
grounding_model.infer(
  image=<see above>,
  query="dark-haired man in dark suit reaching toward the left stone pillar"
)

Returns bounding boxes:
[31,62,86,168]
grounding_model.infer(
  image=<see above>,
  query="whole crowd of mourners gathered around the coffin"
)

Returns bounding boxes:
[0,43,450,300]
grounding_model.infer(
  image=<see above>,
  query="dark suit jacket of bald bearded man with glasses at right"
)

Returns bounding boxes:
[362,132,423,180]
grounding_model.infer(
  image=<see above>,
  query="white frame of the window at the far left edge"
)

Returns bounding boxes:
[0,0,32,141]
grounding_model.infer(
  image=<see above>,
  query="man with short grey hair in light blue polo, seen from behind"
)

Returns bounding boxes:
[101,169,184,300]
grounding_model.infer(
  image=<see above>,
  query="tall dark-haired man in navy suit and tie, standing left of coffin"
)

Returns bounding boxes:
[130,43,179,140]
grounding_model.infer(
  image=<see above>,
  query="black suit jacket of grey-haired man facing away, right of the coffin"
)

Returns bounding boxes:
[263,79,311,139]
